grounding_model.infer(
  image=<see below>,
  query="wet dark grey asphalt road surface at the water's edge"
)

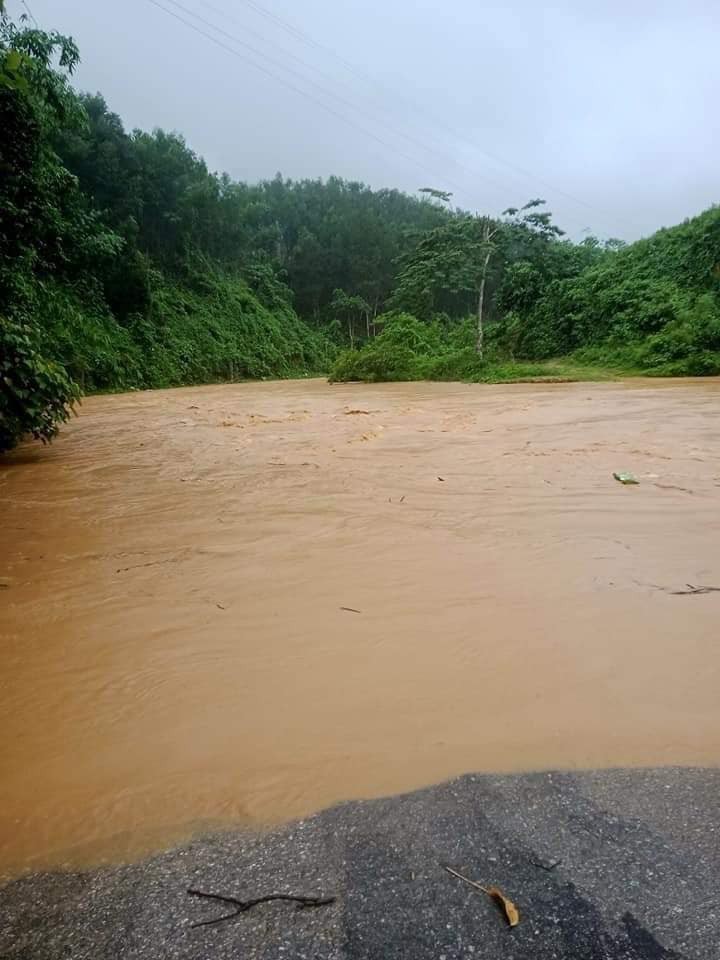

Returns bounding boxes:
[0,768,720,960]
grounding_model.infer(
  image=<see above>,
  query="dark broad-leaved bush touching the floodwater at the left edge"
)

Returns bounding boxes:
[0,317,80,452]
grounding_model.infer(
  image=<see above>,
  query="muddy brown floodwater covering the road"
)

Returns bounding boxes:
[0,380,720,873]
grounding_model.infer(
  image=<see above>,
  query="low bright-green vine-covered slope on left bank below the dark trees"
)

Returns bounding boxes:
[22,271,329,392]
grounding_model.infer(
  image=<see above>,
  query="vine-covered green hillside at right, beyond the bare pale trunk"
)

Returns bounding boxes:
[495,207,720,360]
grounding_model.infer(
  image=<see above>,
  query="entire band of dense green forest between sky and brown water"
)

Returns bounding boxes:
[0,14,720,450]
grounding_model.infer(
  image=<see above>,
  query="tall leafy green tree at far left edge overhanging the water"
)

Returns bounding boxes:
[0,13,120,449]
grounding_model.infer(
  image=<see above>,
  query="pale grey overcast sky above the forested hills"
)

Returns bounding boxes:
[8,0,720,239]
